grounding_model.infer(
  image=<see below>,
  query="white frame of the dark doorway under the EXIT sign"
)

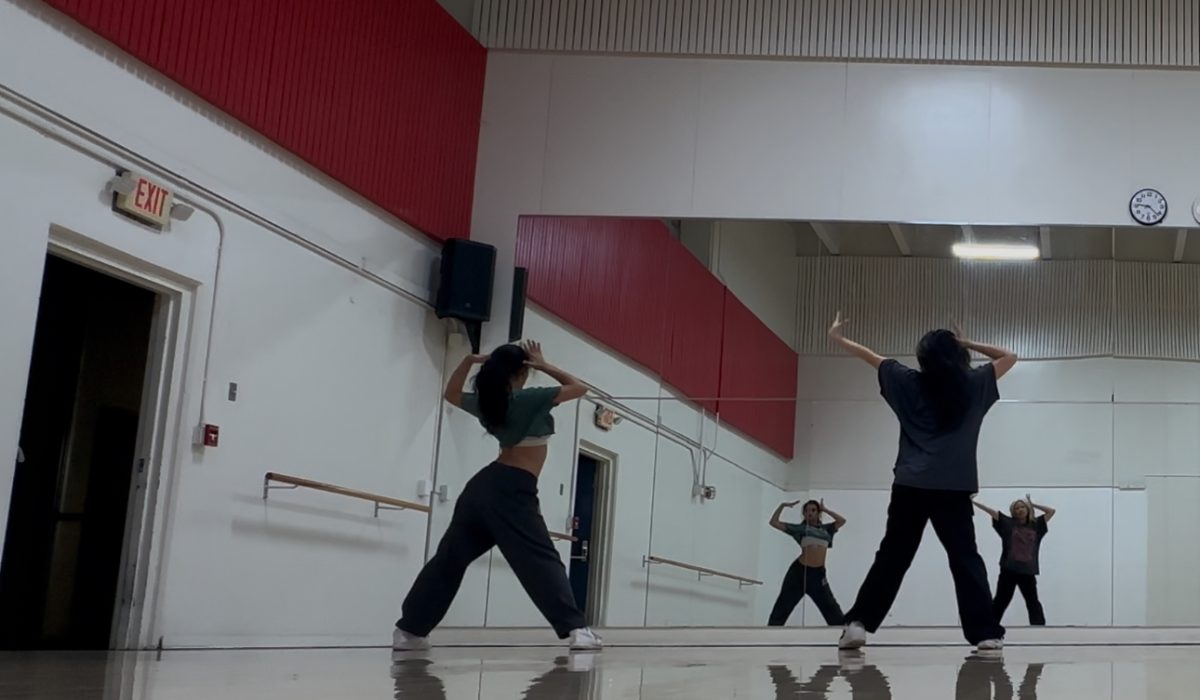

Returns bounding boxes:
[46,225,197,650]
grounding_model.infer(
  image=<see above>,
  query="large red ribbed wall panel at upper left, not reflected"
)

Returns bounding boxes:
[46,0,487,239]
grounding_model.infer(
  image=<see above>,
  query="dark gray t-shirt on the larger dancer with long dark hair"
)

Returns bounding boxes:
[880,360,1000,493]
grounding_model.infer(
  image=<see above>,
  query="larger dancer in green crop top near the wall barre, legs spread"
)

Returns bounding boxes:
[392,342,601,651]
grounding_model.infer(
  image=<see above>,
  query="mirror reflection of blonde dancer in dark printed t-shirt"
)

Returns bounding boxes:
[976,493,1055,627]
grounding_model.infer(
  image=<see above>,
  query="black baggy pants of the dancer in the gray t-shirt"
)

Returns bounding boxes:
[846,484,1004,644]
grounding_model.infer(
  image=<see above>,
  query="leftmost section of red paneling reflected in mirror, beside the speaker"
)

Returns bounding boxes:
[516,216,676,371]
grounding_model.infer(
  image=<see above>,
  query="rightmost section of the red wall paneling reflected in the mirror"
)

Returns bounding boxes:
[720,289,798,459]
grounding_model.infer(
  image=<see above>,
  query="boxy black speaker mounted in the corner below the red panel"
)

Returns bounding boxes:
[433,238,496,323]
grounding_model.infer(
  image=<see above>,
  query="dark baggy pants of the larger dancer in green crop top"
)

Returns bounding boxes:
[396,462,586,639]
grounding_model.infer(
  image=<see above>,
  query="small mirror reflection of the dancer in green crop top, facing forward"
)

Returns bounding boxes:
[767,501,846,627]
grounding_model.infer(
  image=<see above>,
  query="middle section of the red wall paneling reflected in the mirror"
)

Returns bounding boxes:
[661,240,725,412]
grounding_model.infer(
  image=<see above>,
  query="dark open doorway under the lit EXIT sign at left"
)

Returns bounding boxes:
[0,256,156,650]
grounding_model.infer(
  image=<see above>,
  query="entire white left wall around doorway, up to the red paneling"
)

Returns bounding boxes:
[0,1,463,646]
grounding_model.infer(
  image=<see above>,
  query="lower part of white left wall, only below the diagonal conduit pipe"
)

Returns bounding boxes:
[0,83,453,646]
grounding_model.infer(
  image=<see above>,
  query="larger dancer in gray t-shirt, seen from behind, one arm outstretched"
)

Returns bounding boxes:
[829,312,1016,650]
